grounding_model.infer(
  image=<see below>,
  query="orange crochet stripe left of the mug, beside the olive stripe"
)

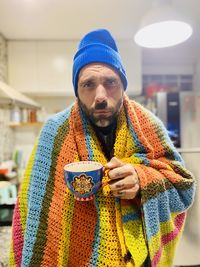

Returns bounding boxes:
[42,120,74,266]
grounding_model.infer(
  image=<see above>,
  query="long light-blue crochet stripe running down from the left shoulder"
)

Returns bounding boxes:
[22,107,71,266]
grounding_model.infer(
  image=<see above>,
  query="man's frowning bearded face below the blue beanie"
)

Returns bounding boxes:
[78,63,124,127]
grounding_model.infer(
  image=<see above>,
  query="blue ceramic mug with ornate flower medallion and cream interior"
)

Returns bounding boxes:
[64,161,104,201]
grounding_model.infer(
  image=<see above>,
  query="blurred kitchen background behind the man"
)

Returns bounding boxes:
[0,0,200,266]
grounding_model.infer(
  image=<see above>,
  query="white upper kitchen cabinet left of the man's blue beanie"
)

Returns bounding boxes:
[8,41,77,96]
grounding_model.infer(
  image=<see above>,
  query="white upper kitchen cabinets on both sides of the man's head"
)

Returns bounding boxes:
[8,40,141,96]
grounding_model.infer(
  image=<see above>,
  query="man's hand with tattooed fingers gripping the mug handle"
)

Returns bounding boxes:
[105,157,140,199]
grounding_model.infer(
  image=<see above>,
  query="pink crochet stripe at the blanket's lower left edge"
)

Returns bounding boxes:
[13,201,24,267]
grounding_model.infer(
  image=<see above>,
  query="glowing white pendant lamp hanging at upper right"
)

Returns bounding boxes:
[134,0,192,48]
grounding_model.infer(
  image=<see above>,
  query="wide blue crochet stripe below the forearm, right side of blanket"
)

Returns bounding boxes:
[143,186,194,241]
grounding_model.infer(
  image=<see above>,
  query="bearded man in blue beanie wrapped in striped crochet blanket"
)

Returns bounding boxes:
[9,29,194,267]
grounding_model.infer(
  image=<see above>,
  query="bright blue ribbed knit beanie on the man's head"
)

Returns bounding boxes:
[73,29,127,96]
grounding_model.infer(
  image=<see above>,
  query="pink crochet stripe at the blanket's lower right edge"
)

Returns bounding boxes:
[151,213,186,267]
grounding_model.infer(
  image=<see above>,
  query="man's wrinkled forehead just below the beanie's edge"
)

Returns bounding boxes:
[79,63,120,79]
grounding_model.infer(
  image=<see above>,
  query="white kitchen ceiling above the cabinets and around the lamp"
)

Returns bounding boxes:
[0,0,200,64]
